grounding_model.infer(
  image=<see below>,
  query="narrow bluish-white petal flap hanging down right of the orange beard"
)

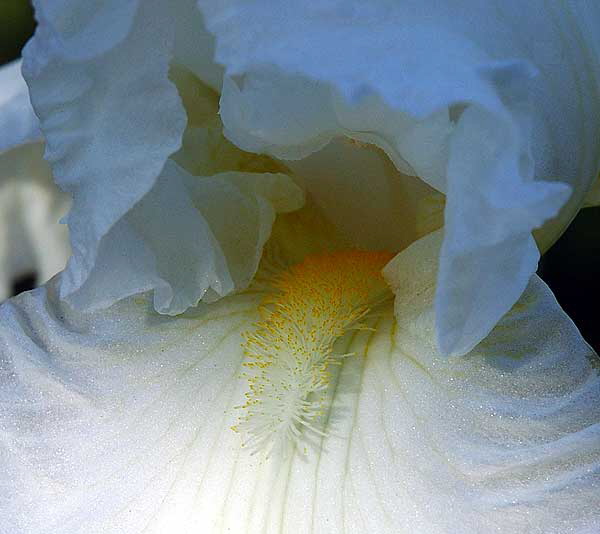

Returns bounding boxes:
[436,104,569,354]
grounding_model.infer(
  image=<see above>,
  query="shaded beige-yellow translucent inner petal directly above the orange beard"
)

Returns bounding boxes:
[286,139,444,251]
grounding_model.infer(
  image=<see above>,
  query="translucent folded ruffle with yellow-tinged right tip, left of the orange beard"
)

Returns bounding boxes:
[65,161,303,314]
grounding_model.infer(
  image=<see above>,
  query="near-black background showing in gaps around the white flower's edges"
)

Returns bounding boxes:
[0,0,600,352]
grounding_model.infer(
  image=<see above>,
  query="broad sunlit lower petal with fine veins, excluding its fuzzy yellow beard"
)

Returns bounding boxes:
[0,239,600,534]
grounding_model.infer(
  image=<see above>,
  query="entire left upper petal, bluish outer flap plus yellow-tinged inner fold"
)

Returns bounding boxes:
[19,0,310,314]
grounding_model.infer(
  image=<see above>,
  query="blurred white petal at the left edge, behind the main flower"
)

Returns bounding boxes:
[0,61,70,301]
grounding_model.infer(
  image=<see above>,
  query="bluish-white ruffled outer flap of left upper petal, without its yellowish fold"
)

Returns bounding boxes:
[19,0,225,316]
